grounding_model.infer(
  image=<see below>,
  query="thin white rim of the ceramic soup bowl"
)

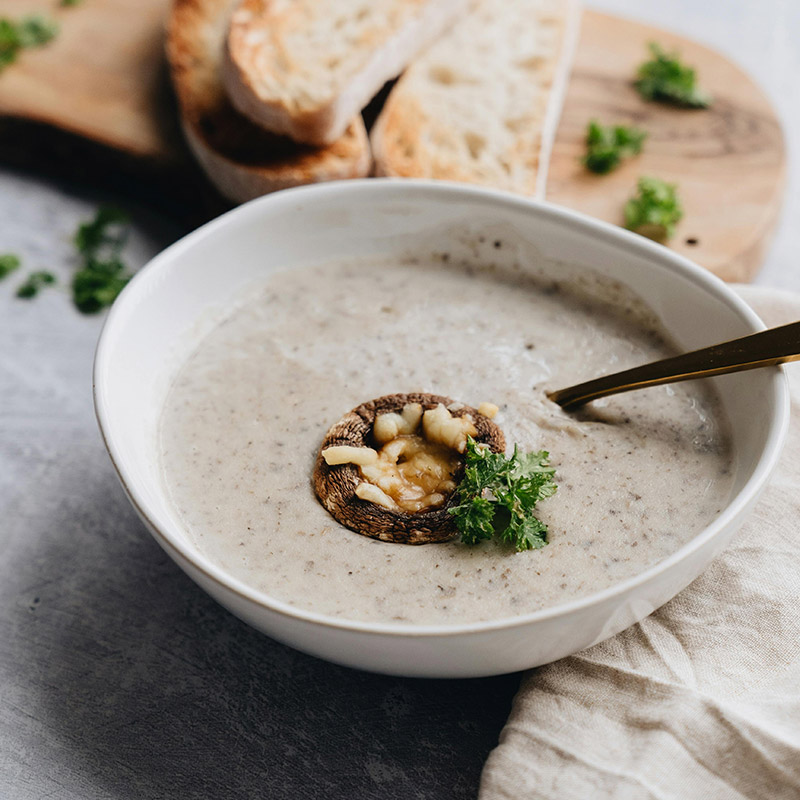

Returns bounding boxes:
[92,178,790,638]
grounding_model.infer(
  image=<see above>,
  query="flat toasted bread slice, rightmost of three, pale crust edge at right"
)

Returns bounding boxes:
[371,0,580,197]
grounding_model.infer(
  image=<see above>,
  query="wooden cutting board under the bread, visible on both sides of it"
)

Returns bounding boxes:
[0,0,785,281]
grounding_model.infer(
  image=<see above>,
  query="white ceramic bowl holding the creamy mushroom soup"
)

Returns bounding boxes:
[95,180,789,677]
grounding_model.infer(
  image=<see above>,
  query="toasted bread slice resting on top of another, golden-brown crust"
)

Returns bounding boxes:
[223,0,472,144]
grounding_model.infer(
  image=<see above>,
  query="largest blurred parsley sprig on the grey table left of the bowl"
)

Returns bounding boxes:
[72,206,131,314]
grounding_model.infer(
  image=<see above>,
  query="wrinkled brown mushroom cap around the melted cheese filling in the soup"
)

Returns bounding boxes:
[314,393,506,544]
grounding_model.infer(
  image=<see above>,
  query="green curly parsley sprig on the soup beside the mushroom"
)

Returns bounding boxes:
[450,437,556,550]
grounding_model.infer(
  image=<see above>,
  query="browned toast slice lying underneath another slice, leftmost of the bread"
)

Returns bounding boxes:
[167,0,371,203]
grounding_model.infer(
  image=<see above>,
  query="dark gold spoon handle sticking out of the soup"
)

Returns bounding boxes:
[547,322,800,408]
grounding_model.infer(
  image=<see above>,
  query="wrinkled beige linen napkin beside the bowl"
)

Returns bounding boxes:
[480,287,800,800]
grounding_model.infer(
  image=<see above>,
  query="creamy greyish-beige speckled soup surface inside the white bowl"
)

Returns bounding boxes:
[161,258,732,624]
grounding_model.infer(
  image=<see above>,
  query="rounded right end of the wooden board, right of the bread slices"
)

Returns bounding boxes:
[547,12,786,281]
